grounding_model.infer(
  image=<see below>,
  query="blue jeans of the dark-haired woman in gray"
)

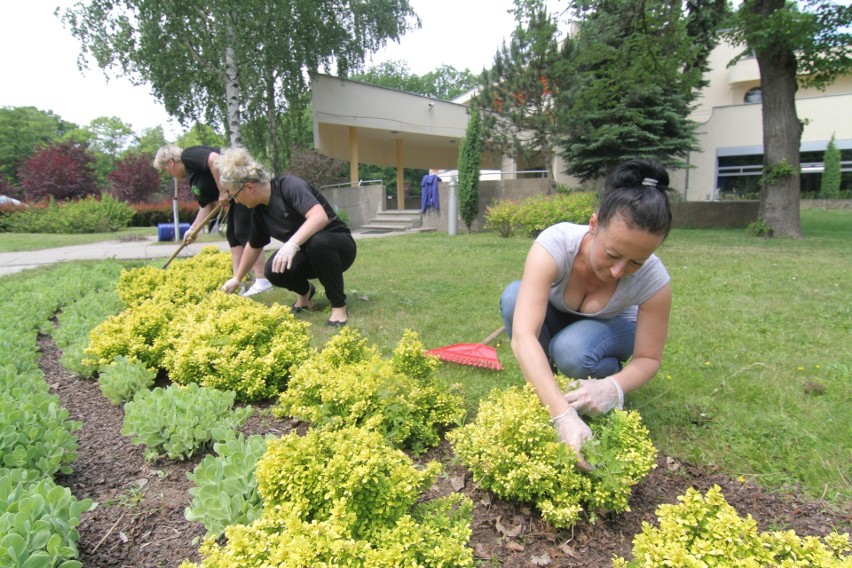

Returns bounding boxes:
[500,280,636,379]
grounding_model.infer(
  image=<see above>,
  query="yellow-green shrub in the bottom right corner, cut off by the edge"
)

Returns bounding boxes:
[613,485,852,568]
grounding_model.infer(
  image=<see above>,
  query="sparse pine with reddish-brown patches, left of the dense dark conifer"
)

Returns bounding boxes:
[476,0,560,189]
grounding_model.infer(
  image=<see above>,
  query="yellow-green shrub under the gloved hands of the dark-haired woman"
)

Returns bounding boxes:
[447,378,656,527]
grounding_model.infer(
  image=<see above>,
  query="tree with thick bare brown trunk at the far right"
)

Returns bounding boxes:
[729,0,852,238]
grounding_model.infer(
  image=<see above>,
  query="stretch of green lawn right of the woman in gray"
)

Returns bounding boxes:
[628,210,852,502]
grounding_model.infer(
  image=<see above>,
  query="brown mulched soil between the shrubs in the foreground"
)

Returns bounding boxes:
[39,336,852,568]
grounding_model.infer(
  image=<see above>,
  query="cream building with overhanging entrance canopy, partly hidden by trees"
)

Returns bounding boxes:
[312,43,852,201]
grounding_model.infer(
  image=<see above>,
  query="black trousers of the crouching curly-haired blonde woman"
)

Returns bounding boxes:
[266,231,357,308]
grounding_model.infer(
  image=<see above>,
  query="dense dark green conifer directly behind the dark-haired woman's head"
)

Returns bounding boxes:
[558,0,725,180]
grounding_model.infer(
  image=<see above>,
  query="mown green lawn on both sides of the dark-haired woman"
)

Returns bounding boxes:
[3,209,852,506]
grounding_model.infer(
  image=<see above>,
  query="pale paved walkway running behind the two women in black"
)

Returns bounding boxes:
[0,231,416,276]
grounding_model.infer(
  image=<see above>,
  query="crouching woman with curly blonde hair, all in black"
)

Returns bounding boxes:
[219,148,356,326]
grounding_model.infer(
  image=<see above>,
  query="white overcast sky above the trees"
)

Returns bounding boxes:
[0,0,565,138]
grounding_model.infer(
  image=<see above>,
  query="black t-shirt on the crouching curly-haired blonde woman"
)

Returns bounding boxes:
[249,176,349,248]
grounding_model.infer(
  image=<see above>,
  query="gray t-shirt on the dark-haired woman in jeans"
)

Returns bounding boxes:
[535,223,671,321]
